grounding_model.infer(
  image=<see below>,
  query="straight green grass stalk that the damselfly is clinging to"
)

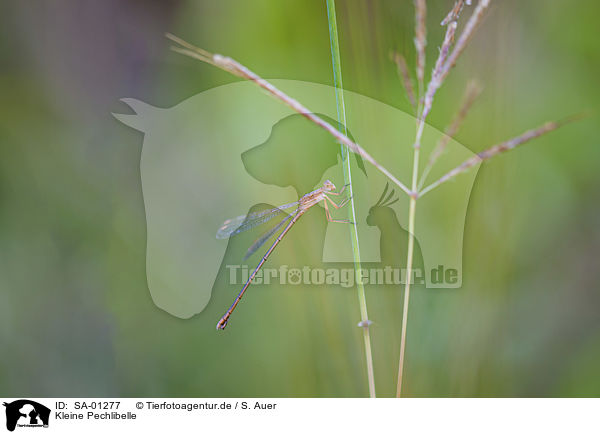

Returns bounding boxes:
[326,0,376,398]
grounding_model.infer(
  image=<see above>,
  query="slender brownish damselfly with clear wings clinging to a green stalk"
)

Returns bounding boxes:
[217,180,353,330]
